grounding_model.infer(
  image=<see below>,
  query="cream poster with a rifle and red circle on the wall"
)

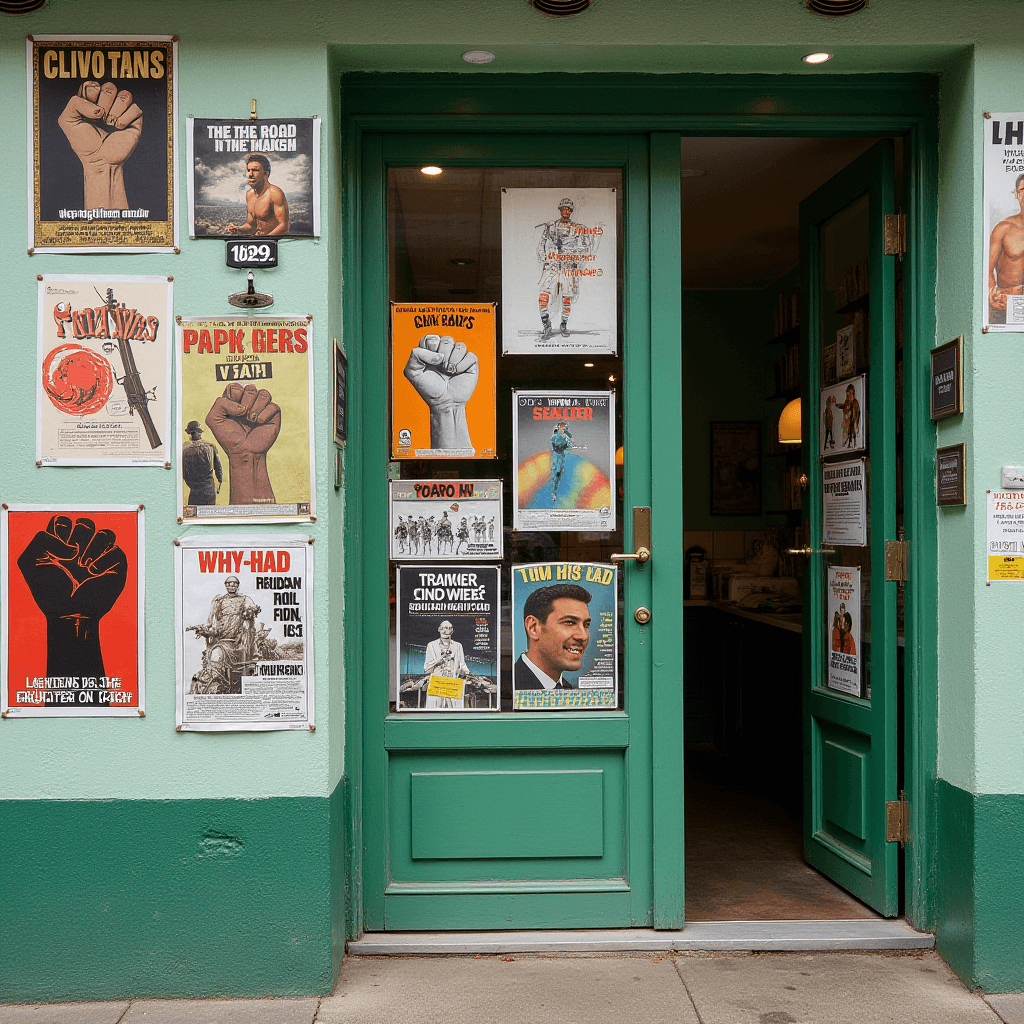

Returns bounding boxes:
[36,273,173,469]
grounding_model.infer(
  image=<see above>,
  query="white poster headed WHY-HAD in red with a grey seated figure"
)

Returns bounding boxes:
[174,534,314,732]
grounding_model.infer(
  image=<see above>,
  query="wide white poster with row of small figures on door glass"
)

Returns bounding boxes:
[388,480,504,562]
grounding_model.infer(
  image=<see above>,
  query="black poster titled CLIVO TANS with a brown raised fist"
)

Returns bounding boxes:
[28,35,178,253]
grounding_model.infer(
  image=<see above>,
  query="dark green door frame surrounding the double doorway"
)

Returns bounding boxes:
[339,72,939,938]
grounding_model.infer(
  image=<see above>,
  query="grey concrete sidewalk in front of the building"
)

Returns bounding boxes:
[0,951,1024,1024]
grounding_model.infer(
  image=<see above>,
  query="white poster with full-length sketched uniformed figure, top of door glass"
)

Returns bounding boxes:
[502,187,618,355]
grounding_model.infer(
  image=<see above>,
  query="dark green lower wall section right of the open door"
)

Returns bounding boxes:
[935,779,1024,992]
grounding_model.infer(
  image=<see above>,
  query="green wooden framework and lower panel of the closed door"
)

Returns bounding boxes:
[356,133,683,931]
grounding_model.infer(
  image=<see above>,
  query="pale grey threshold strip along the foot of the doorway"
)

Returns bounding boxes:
[348,918,935,956]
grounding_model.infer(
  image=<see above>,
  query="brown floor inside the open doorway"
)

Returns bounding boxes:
[685,745,881,922]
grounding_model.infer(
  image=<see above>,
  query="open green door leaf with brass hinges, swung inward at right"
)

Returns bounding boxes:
[800,140,898,916]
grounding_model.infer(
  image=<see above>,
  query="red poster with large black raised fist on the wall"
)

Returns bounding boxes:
[0,505,145,718]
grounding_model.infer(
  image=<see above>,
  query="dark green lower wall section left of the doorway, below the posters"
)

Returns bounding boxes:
[0,783,346,1002]
